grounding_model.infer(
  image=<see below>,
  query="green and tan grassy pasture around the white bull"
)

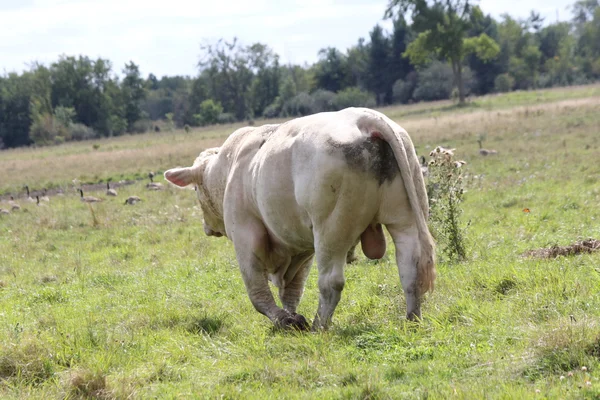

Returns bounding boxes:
[0,86,600,399]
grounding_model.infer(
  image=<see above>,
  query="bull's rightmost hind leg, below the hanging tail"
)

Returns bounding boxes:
[387,225,421,321]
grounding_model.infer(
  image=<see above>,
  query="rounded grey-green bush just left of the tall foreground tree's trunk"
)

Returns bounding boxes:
[414,61,454,101]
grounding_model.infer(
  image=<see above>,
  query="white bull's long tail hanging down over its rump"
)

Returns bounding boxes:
[358,110,436,294]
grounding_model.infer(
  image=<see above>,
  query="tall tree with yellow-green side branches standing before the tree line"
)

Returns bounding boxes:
[386,0,500,104]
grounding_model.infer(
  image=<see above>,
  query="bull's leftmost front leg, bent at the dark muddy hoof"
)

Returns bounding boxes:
[233,217,309,330]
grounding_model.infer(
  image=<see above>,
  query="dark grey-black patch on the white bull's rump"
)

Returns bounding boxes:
[327,137,400,185]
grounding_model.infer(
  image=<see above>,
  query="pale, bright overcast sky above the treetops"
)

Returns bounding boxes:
[0,0,574,77]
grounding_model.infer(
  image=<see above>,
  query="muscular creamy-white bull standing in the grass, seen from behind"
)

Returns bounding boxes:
[165,108,435,330]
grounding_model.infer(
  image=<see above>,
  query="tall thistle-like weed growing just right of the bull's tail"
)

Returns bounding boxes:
[427,147,467,261]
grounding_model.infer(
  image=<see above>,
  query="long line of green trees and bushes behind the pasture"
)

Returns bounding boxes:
[0,0,600,149]
